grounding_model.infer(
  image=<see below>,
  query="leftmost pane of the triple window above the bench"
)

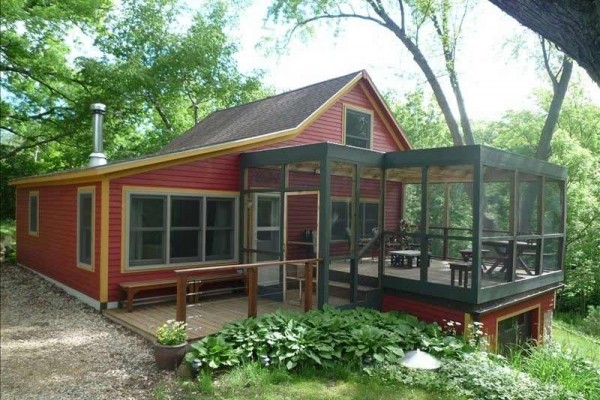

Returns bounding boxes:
[129,195,167,266]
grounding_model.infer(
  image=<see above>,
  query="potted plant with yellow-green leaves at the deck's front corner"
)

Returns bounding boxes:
[154,319,187,370]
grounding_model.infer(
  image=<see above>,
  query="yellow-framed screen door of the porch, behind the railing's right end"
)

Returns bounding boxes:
[283,190,319,307]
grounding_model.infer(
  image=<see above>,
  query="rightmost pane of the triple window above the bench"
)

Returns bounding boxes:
[205,197,235,260]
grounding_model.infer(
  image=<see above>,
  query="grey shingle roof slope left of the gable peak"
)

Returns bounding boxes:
[160,71,361,153]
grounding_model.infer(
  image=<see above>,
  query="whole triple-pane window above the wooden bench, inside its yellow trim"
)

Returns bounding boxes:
[128,194,236,267]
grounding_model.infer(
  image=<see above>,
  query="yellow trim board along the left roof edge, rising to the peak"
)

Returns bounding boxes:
[9,72,364,186]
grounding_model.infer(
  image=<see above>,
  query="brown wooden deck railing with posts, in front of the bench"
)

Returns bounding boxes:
[175,258,320,322]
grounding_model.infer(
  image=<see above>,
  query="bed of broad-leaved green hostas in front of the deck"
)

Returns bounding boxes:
[186,308,469,370]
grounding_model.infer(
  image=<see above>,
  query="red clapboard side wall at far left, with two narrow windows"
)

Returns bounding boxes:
[17,183,101,299]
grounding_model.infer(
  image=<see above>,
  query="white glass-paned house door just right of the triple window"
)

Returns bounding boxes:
[252,193,281,290]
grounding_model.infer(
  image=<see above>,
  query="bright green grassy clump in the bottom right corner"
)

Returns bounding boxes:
[510,344,600,399]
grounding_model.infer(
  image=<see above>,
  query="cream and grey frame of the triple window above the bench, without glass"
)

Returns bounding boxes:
[121,188,239,272]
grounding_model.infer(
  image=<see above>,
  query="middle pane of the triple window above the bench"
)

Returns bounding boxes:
[169,197,203,262]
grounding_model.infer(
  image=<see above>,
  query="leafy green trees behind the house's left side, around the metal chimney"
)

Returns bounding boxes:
[0,0,265,218]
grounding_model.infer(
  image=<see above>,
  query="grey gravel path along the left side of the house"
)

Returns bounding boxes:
[0,265,172,400]
